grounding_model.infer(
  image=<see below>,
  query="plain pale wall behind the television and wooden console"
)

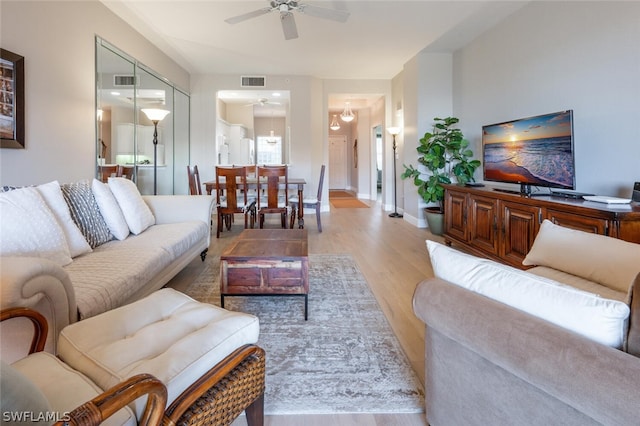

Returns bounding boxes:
[452,1,640,197]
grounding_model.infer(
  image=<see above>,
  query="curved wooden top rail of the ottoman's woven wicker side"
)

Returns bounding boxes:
[164,344,265,426]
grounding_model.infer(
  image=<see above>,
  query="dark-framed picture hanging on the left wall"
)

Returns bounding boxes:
[0,49,25,149]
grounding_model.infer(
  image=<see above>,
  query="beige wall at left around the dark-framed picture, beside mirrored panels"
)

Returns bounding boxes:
[0,0,189,185]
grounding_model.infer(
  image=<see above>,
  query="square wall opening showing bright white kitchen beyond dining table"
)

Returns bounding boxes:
[216,90,290,165]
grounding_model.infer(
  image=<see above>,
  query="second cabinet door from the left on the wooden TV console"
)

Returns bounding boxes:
[468,195,499,255]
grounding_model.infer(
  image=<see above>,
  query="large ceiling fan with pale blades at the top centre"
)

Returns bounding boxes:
[225,0,349,40]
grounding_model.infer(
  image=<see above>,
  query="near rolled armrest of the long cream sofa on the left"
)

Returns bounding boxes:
[0,256,78,361]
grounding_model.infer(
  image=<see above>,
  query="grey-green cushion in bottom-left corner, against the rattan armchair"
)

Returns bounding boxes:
[0,361,51,425]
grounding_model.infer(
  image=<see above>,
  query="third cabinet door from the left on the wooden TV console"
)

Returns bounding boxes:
[500,201,542,267]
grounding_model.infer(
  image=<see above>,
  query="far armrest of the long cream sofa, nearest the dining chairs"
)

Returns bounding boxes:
[142,195,215,225]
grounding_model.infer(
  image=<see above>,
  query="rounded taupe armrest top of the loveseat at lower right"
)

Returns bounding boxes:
[413,278,640,424]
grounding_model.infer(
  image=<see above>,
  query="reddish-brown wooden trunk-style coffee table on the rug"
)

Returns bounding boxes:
[220,229,309,320]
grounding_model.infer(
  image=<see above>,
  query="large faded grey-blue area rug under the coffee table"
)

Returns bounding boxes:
[186,255,424,414]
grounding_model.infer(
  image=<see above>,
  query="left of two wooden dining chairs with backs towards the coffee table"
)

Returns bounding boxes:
[216,166,256,238]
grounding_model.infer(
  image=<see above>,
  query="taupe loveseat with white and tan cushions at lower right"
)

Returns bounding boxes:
[413,222,640,426]
